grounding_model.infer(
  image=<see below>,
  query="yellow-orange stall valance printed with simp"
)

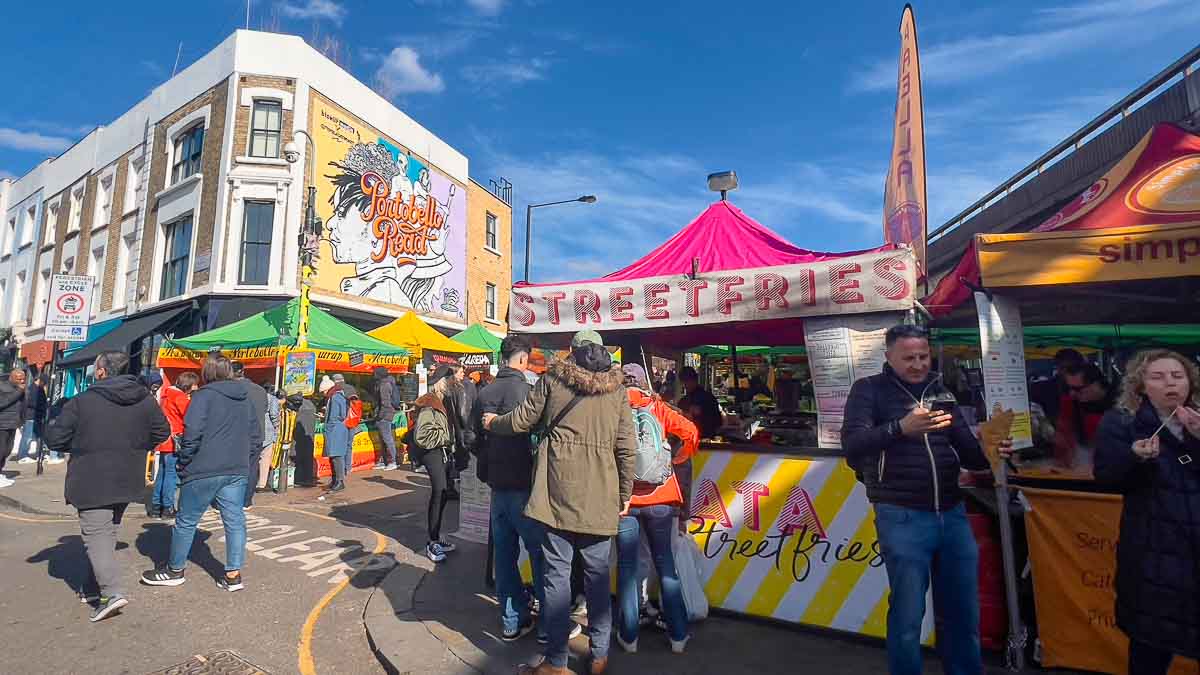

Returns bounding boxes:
[976,220,1200,288]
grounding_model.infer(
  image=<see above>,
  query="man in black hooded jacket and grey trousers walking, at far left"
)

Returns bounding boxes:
[46,352,170,621]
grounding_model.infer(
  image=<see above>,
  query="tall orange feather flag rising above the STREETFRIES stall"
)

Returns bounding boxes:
[883,5,928,279]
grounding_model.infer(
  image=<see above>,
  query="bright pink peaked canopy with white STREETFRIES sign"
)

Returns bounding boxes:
[509,201,916,348]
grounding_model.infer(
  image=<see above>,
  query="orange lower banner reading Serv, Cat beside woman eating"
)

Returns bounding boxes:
[1021,488,1198,675]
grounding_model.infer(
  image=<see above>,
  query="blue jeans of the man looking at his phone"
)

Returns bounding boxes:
[875,503,983,675]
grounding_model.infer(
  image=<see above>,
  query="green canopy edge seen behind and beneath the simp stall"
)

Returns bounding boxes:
[932,323,1200,350]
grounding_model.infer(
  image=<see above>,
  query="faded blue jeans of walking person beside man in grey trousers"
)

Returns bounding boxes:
[167,476,246,572]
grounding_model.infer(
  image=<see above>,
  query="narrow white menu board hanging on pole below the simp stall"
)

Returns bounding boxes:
[974,293,1033,448]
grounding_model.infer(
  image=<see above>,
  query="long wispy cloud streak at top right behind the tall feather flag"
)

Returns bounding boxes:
[850,0,1200,91]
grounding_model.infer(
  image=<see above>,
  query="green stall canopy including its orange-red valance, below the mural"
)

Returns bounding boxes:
[158,300,408,372]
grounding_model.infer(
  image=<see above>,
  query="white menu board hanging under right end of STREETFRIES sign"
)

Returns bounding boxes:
[804,312,904,448]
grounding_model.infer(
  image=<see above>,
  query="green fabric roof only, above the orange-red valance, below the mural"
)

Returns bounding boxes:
[169,299,408,357]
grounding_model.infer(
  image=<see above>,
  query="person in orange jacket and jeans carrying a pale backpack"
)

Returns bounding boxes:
[617,364,700,653]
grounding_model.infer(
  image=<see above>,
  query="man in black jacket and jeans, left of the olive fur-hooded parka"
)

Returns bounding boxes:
[472,335,544,640]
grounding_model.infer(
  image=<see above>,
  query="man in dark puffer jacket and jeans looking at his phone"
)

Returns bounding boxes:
[841,325,1008,675]
